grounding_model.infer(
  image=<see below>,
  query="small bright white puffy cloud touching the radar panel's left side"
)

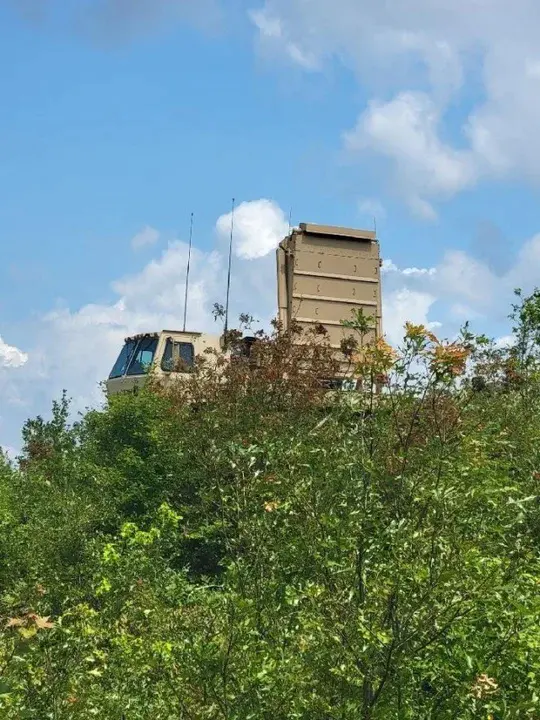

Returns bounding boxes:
[216,199,289,260]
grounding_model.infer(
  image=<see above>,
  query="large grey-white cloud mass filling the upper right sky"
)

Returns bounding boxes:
[251,0,540,214]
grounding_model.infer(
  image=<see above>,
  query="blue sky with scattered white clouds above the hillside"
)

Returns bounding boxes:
[0,0,540,448]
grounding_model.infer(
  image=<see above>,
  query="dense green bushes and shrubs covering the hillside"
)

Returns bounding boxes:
[0,293,540,720]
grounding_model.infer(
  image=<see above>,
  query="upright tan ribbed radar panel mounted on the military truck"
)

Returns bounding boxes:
[277,223,382,349]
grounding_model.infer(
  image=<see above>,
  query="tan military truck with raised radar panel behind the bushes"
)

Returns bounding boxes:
[106,223,382,395]
